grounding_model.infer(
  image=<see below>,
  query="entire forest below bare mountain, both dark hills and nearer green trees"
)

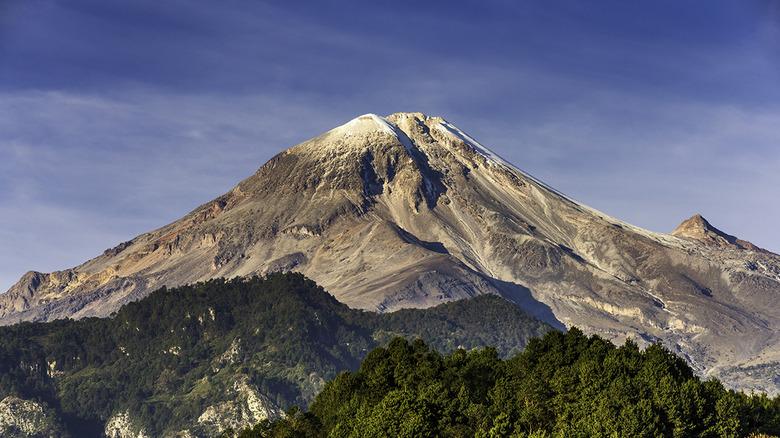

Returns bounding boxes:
[0,273,780,438]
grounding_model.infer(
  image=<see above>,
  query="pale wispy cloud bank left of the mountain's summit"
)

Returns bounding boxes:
[0,90,344,288]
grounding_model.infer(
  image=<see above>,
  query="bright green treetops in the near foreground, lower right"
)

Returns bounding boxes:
[222,328,780,438]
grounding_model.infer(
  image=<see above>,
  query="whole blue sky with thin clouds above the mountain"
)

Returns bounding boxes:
[0,0,780,291]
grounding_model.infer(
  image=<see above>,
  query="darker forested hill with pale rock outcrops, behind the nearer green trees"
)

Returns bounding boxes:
[0,273,550,437]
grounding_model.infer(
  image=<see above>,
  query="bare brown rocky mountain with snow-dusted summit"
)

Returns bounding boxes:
[0,113,780,393]
